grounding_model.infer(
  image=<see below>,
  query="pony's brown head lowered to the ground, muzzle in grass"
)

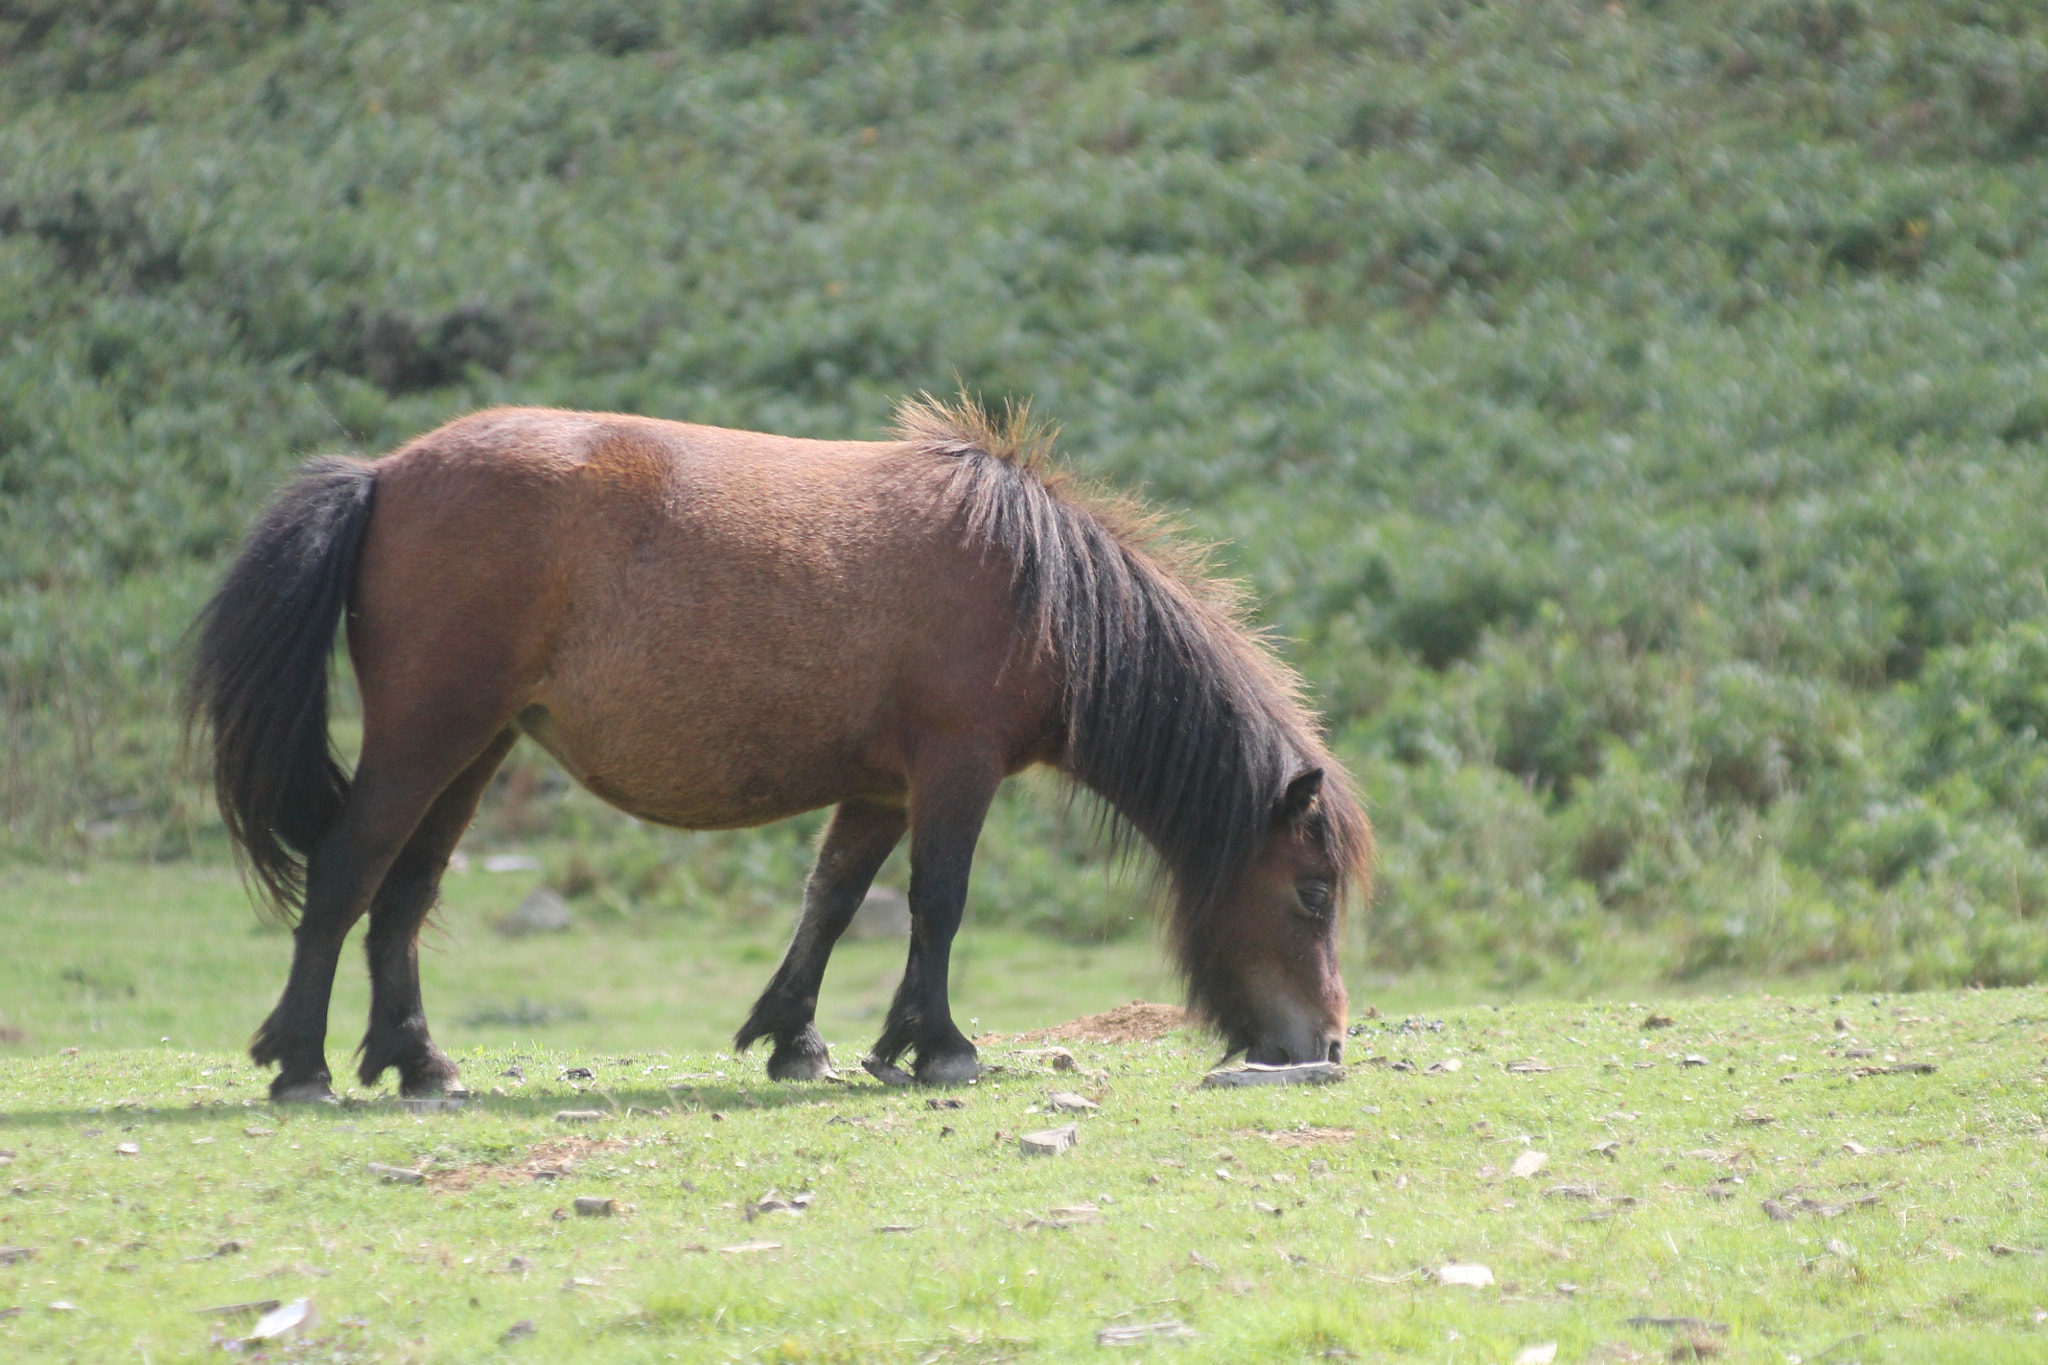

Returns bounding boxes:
[1182,767,1370,1064]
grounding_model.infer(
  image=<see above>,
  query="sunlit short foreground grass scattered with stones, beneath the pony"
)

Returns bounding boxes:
[0,988,2048,1365]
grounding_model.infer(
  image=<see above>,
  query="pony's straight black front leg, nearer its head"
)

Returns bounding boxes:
[868,767,1001,1085]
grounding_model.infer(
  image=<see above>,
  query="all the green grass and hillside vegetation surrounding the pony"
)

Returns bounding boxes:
[12,0,2048,1365]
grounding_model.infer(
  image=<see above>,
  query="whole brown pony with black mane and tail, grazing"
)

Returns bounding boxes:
[190,401,1372,1099]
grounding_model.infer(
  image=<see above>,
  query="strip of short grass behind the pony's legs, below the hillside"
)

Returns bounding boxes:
[0,864,1174,1072]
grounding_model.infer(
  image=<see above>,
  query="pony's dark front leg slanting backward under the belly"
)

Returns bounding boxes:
[733,800,909,1081]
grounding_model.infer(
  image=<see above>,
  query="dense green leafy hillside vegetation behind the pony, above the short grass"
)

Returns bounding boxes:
[0,0,2048,986]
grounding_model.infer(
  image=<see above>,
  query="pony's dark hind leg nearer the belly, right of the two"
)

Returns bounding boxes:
[356,729,516,1097]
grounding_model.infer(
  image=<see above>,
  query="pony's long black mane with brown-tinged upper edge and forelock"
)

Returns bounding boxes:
[899,401,1372,1007]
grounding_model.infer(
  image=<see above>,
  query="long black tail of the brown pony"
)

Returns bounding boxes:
[184,456,377,919]
